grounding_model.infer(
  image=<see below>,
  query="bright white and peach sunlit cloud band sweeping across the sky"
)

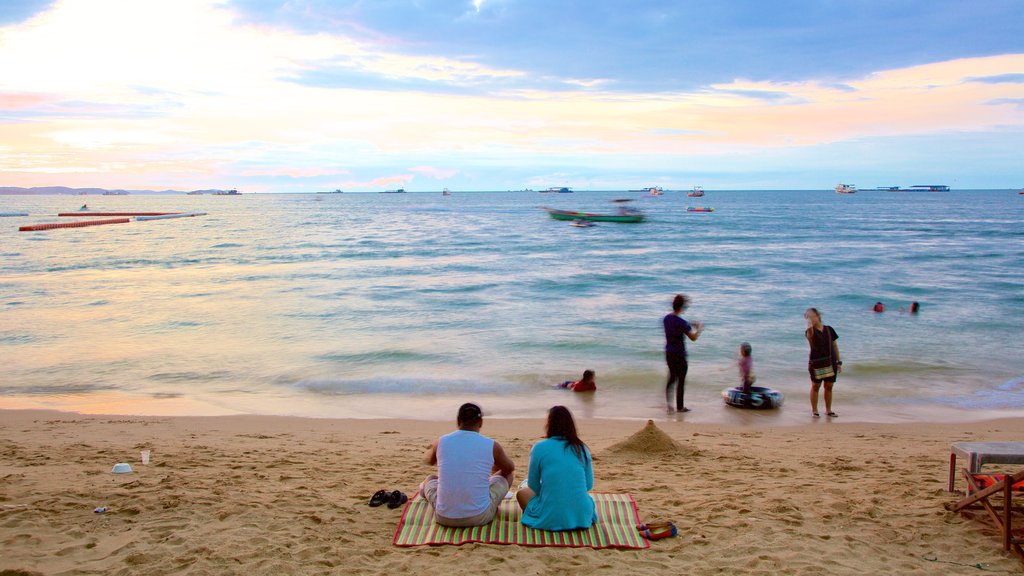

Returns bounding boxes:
[0,0,1024,190]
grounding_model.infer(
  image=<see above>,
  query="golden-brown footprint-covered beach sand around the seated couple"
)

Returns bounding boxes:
[0,410,1024,575]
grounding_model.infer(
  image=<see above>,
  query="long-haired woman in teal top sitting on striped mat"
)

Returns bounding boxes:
[516,406,597,530]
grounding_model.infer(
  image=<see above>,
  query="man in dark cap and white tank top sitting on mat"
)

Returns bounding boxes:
[420,403,515,527]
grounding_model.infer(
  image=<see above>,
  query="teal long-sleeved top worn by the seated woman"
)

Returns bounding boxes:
[522,437,597,530]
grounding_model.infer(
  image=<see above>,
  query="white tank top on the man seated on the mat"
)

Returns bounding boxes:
[436,430,495,519]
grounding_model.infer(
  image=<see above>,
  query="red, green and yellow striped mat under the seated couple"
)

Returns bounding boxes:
[393,493,650,548]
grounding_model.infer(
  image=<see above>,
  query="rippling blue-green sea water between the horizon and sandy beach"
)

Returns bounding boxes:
[0,191,1024,424]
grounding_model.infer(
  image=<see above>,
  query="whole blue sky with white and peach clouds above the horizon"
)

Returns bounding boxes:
[0,0,1024,193]
